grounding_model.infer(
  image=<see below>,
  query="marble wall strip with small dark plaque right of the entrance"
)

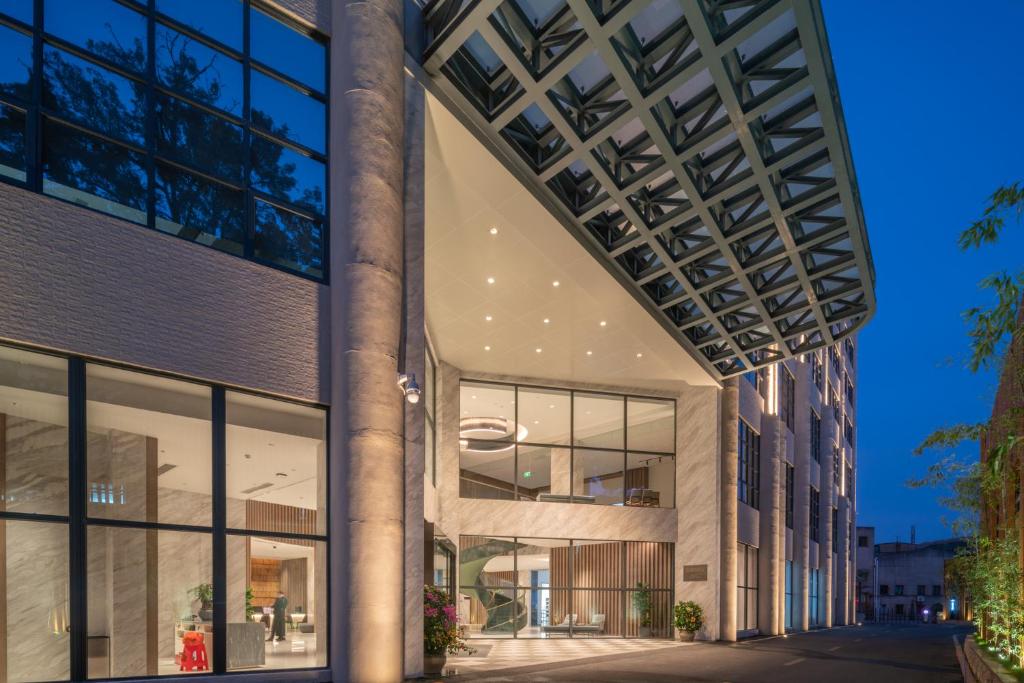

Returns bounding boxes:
[674,387,721,640]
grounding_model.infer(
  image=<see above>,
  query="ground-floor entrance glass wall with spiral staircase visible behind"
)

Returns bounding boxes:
[458,536,674,638]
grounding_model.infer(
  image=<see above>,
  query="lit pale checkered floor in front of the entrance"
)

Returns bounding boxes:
[445,638,688,675]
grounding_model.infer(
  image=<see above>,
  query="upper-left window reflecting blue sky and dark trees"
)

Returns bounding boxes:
[0,0,328,280]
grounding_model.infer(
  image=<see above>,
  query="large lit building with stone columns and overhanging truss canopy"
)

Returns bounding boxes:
[0,0,874,683]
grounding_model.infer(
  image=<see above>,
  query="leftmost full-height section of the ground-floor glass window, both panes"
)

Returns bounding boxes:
[0,348,70,681]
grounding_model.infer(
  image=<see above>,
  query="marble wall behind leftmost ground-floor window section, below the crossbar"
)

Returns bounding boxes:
[0,521,70,683]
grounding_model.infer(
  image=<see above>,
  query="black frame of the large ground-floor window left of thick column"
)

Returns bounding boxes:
[0,335,332,683]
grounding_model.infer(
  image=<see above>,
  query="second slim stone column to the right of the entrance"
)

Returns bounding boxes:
[758,415,784,636]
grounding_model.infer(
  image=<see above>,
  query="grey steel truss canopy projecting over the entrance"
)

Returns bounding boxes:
[423,0,874,379]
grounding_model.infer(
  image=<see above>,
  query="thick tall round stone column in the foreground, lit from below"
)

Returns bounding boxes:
[330,0,405,682]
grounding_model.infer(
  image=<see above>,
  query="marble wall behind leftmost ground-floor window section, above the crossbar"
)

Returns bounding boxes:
[0,415,68,515]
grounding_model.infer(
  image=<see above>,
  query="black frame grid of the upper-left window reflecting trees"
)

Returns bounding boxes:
[0,0,331,284]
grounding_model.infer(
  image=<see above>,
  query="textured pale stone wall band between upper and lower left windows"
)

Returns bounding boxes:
[0,184,330,402]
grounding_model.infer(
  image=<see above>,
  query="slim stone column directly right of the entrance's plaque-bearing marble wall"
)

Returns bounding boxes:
[719,378,739,641]
